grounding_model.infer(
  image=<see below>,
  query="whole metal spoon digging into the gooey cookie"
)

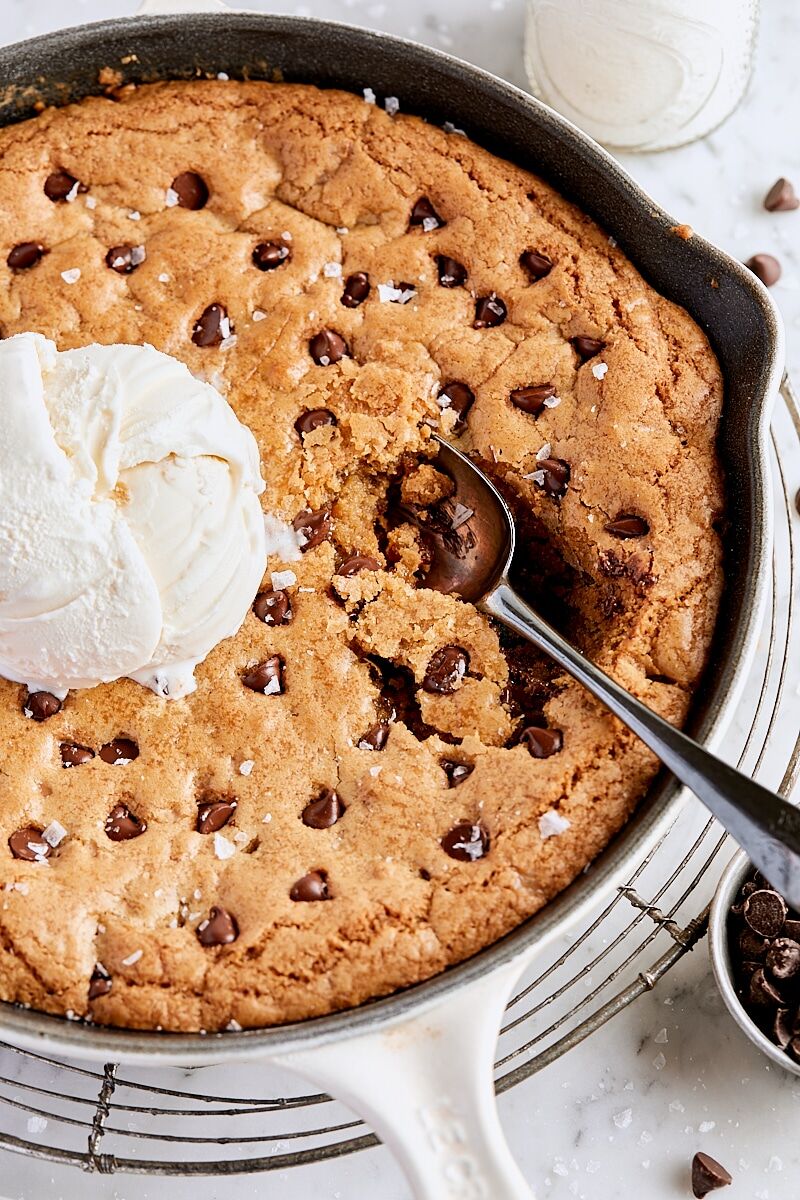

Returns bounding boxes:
[426,438,800,908]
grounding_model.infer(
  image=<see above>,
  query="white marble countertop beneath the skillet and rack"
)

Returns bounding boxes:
[0,0,800,1200]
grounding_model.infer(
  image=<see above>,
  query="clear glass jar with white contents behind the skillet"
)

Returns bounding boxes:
[525,0,759,150]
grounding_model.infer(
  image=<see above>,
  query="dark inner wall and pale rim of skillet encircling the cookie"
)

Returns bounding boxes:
[0,13,783,1064]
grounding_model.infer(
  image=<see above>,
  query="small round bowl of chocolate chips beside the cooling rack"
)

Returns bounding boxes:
[709,851,800,1075]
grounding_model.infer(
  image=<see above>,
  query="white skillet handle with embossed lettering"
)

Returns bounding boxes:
[276,960,534,1200]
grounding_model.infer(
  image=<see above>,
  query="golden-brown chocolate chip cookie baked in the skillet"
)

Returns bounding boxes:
[0,82,723,1030]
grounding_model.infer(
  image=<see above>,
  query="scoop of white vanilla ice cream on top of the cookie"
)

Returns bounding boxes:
[0,334,266,698]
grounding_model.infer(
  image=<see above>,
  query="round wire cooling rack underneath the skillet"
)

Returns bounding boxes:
[0,380,800,1176]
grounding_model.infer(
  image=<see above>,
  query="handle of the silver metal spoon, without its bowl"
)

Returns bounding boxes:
[481,581,800,908]
